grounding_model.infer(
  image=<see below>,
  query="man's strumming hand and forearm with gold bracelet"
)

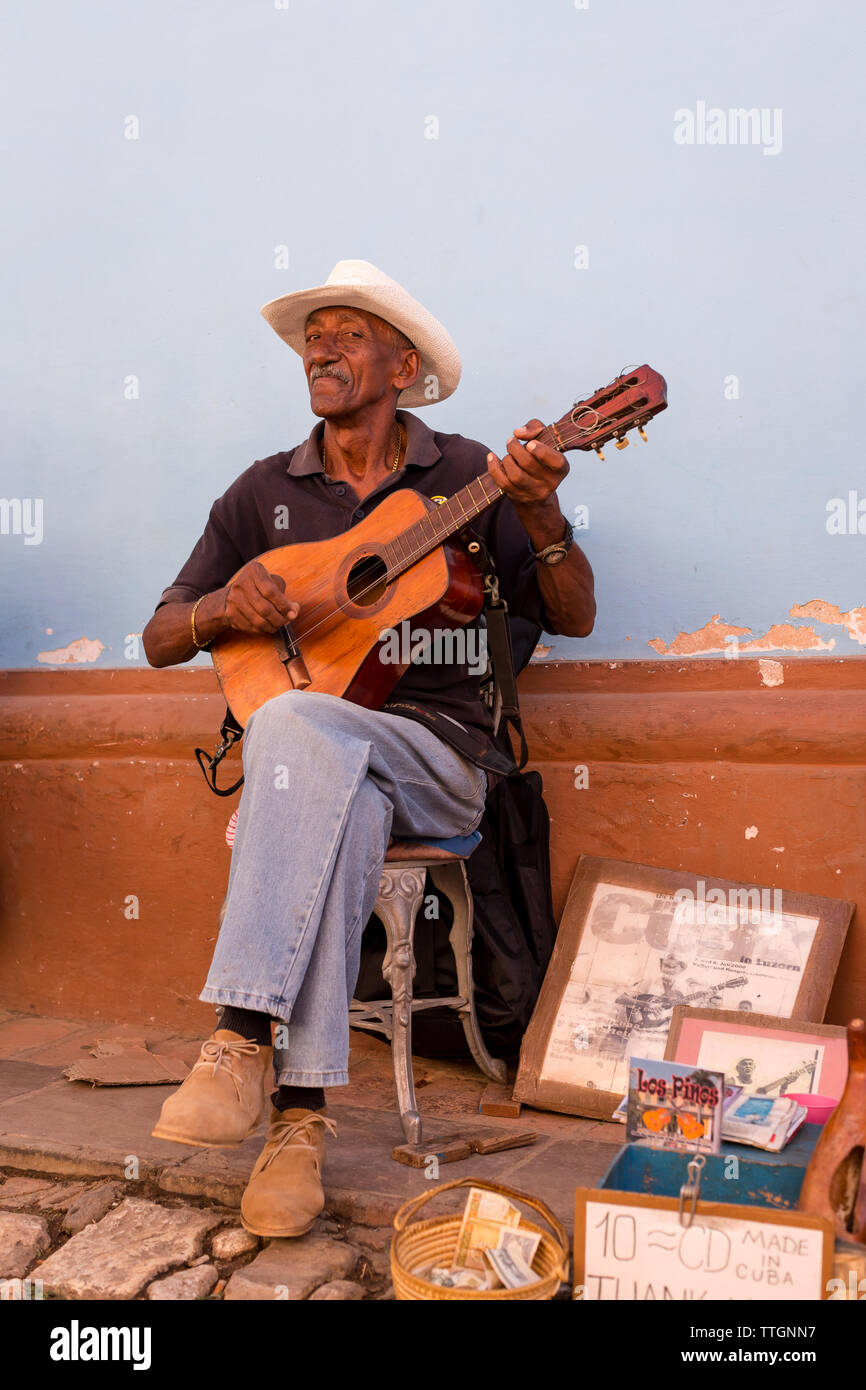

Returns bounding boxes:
[142,560,300,667]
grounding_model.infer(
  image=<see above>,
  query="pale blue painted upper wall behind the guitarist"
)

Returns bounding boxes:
[0,0,866,666]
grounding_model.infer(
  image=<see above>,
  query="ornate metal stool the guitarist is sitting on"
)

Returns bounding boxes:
[349,831,506,1144]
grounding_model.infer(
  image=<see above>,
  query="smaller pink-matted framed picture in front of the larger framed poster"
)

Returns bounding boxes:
[664,1004,848,1101]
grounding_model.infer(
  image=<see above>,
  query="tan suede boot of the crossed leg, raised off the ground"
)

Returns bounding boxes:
[153,1029,274,1148]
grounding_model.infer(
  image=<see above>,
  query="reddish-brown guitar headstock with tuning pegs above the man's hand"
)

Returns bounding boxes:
[539,364,667,461]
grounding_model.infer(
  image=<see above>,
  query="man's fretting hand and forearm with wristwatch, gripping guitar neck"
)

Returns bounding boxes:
[487,420,595,637]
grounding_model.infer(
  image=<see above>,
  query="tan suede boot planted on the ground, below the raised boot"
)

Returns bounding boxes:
[240,1106,336,1237]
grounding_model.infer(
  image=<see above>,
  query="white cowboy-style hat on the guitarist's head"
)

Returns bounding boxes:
[261,261,460,406]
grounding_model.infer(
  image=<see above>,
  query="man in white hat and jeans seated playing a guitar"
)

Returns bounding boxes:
[143,261,595,1236]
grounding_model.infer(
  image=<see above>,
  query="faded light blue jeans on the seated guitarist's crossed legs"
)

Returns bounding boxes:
[200,691,487,1086]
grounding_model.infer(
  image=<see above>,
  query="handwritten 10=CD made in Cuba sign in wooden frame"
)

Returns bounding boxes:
[574,1187,833,1302]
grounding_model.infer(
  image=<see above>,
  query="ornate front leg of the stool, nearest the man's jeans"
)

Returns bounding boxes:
[375,865,427,1144]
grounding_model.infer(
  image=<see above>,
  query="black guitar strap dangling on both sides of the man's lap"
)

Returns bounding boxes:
[195,531,530,796]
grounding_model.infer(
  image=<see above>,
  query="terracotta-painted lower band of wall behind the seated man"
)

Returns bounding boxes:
[0,657,866,1033]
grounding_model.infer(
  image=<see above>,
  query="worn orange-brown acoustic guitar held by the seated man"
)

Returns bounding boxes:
[211,366,667,724]
